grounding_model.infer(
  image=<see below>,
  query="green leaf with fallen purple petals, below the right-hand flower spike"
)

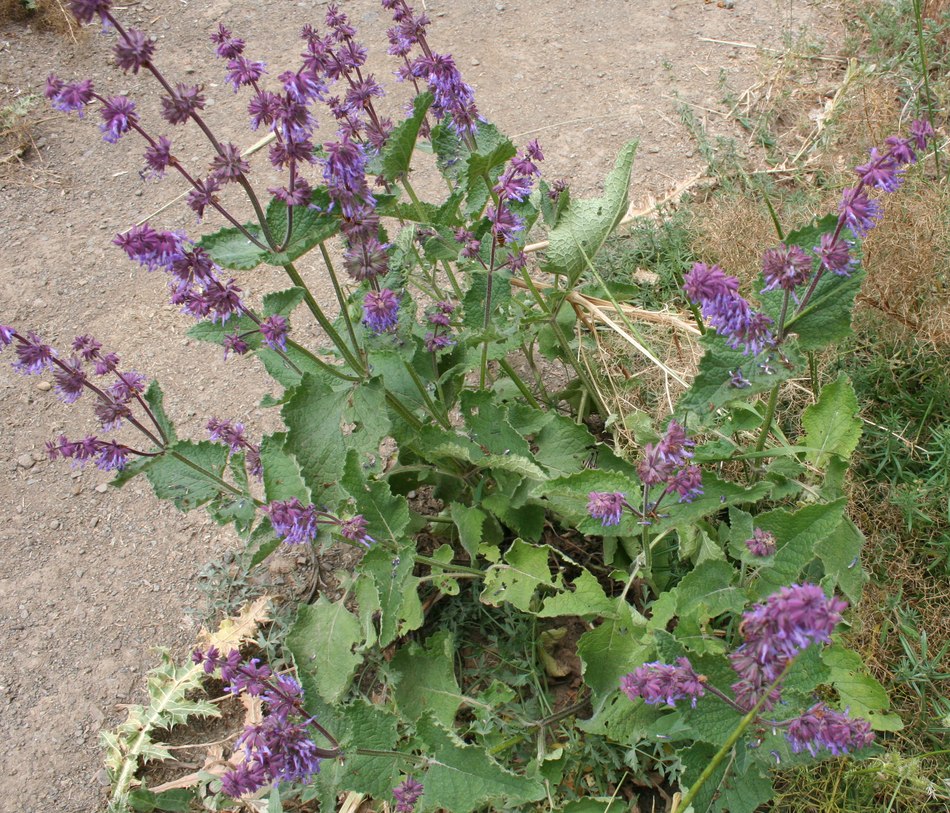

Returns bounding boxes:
[676,330,800,426]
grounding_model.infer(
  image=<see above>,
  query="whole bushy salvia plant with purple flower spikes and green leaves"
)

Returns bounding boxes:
[0,0,933,813]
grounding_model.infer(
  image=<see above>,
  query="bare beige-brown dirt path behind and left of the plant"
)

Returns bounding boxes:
[0,0,825,813]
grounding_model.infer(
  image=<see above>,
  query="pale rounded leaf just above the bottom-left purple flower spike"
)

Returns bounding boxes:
[287,595,363,703]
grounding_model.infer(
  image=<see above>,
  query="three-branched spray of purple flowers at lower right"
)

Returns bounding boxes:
[620,584,874,756]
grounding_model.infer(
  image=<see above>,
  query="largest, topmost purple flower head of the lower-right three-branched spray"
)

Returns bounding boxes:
[730,584,848,709]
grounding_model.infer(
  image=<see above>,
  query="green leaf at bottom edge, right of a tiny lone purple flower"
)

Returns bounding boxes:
[416,717,545,813]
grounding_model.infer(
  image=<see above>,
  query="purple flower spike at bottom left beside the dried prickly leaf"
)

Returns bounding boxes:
[192,647,337,799]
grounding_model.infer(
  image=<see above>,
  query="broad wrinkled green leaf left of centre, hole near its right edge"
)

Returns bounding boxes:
[280,374,350,501]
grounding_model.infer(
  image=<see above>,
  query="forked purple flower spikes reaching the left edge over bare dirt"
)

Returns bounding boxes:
[0,325,164,471]
